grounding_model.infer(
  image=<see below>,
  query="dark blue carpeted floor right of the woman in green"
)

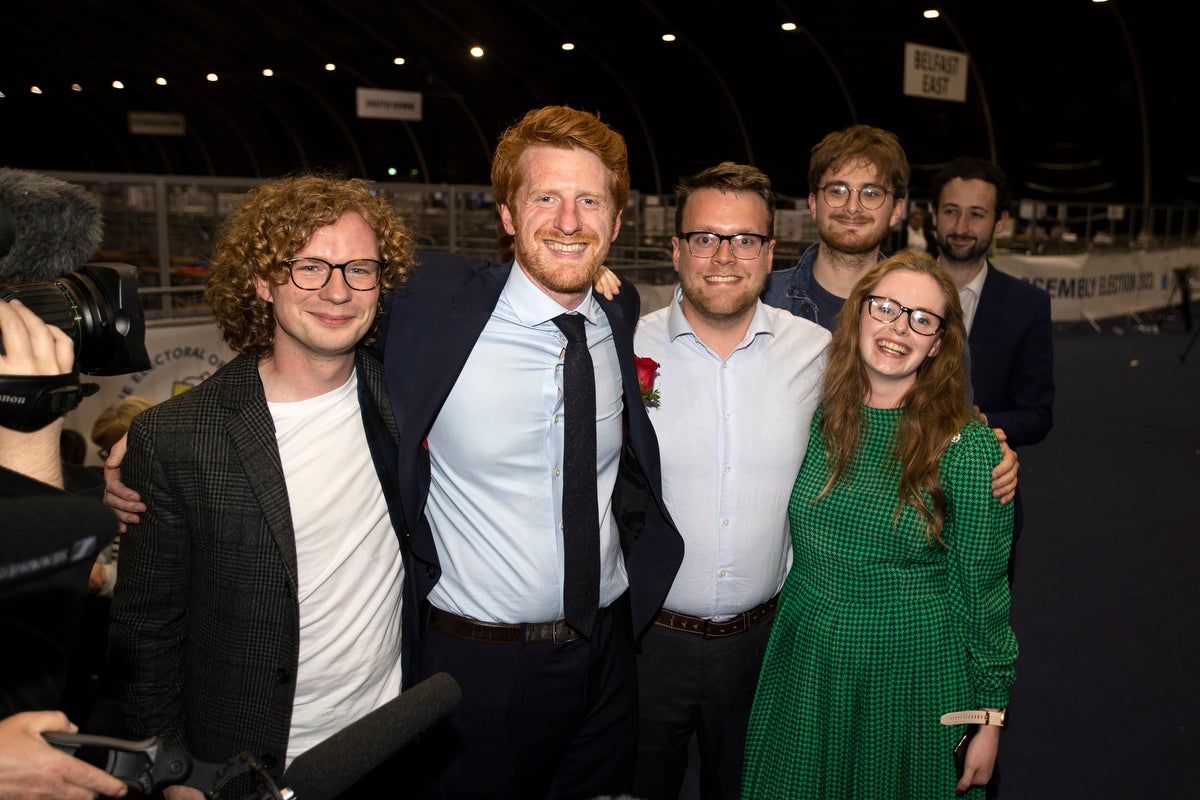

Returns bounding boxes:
[1000,321,1200,800]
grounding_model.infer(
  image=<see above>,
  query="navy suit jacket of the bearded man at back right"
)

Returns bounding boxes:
[967,261,1054,450]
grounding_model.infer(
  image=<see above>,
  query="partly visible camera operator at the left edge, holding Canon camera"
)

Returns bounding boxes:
[0,300,127,800]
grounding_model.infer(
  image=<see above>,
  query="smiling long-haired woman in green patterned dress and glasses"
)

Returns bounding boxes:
[743,252,1016,800]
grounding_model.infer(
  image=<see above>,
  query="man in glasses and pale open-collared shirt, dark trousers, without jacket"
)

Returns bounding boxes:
[632,162,829,800]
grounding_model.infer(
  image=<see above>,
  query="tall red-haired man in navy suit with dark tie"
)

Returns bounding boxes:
[380,107,683,798]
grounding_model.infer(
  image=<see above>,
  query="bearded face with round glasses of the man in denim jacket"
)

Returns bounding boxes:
[809,160,904,255]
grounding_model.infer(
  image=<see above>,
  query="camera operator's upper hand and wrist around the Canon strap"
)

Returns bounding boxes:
[0,300,74,488]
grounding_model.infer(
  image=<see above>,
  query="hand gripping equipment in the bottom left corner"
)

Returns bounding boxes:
[0,711,128,800]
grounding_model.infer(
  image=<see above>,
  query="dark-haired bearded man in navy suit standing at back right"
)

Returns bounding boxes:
[934,157,1054,583]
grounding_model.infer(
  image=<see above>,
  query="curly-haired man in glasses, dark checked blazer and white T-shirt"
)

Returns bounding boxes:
[109,176,415,798]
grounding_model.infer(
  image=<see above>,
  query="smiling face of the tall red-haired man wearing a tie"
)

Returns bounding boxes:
[500,146,620,308]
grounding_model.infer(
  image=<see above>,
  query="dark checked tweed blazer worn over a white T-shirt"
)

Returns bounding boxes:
[110,350,415,776]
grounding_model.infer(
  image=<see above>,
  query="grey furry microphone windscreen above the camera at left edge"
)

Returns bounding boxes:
[0,167,104,283]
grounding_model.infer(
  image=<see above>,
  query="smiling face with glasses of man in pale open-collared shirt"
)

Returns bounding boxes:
[672,188,775,326]
